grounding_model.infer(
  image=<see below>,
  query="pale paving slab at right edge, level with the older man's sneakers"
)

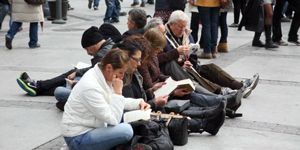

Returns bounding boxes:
[225,56,300,82]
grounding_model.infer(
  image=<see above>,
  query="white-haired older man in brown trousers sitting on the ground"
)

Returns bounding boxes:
[149,11,259,98]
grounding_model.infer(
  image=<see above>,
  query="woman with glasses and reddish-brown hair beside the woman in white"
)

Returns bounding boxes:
[116,35,168,110]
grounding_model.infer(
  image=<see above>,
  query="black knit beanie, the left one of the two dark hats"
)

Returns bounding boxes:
[81,26,104,48]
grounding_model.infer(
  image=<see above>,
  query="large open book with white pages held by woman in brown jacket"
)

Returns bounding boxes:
[154,77,195,97]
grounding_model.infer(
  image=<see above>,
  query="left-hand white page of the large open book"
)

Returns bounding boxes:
[154,77,177,97]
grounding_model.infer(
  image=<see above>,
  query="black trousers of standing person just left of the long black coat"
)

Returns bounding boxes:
[232,0,246,24]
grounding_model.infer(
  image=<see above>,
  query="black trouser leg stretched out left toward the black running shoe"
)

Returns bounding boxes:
[36,69,75,96]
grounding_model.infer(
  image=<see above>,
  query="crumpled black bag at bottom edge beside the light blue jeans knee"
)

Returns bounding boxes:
[130,120,174,150]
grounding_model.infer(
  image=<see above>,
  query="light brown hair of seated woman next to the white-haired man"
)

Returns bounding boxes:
[144,28,167,63]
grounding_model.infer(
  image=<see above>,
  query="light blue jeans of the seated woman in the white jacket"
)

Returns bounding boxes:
[64,123,133,150]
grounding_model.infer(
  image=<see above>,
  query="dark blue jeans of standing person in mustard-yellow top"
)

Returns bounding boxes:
[198,7,220,53]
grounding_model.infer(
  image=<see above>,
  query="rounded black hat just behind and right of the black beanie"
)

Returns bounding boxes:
[99,23,122,43]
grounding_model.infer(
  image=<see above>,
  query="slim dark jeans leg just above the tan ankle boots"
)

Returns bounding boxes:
[219,12,228,43]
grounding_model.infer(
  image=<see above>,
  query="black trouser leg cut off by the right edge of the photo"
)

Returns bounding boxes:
[288,11,300,41]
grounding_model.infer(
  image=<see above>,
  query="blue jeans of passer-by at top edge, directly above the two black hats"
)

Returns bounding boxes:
[103,0,119,21]
